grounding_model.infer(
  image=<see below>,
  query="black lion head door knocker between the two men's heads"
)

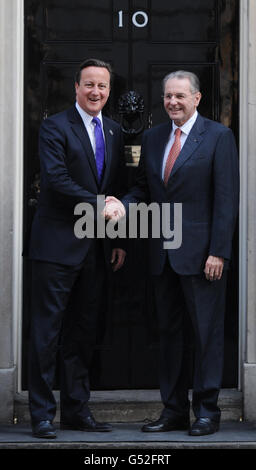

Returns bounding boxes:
[118,91,144,135]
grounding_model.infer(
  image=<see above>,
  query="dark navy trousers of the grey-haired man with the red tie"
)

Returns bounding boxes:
[154,263,226,421]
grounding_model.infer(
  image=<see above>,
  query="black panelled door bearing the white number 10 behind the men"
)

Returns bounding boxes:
[23,0,239,389]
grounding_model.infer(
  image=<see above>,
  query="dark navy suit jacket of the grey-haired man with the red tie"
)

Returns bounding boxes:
[123,115,239,275]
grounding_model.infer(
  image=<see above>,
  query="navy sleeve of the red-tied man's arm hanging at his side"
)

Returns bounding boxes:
[209,129,239,259]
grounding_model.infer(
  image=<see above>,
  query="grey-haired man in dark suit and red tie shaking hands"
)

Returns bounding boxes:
[105,71,239,436]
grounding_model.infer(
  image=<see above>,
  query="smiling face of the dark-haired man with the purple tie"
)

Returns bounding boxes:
[75,66,110,116]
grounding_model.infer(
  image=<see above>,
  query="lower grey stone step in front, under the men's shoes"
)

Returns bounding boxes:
[0,421,256,450]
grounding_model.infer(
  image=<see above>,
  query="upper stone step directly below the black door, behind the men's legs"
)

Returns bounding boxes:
[14,389,243,423]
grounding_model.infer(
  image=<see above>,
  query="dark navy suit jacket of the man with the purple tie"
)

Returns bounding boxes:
[29,106,124,265]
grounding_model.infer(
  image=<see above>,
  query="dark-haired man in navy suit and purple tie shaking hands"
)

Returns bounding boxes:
[29,59,125,438]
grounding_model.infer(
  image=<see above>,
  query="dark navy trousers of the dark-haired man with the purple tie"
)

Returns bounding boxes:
[29,244,105,423]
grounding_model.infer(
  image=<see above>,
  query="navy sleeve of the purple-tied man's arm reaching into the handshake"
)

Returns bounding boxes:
[39,119,97,206]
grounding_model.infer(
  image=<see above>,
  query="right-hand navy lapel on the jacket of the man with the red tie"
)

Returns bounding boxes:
[170,114,205,179]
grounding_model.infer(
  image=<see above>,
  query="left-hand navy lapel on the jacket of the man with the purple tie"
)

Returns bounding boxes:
[69,107,98,185]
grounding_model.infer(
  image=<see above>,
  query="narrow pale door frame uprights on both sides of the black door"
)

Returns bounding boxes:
[12,0,249,393]
